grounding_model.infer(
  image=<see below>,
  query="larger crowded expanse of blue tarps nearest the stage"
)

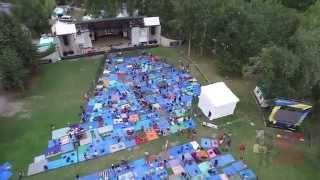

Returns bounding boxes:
[33,55,201,172]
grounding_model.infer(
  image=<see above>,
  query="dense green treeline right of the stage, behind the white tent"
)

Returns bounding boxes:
[162,0,320,101]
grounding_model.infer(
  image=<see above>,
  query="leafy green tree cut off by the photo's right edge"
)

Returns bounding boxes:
[292,1,320,102]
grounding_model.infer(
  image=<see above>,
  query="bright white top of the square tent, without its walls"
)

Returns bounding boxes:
[200,82,239,107]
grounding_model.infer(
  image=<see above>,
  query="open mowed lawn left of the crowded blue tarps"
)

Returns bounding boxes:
[0,58,102,179]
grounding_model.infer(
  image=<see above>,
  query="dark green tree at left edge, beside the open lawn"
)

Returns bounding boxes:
[0,13,38,89]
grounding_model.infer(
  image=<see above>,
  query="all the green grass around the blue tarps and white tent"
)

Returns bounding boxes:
[0,48,320,180]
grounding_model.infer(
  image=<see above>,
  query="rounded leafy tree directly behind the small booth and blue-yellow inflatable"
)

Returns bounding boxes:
[245,46,303,98]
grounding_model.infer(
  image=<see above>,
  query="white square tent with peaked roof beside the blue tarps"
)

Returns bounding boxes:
[198,82,239,120]
